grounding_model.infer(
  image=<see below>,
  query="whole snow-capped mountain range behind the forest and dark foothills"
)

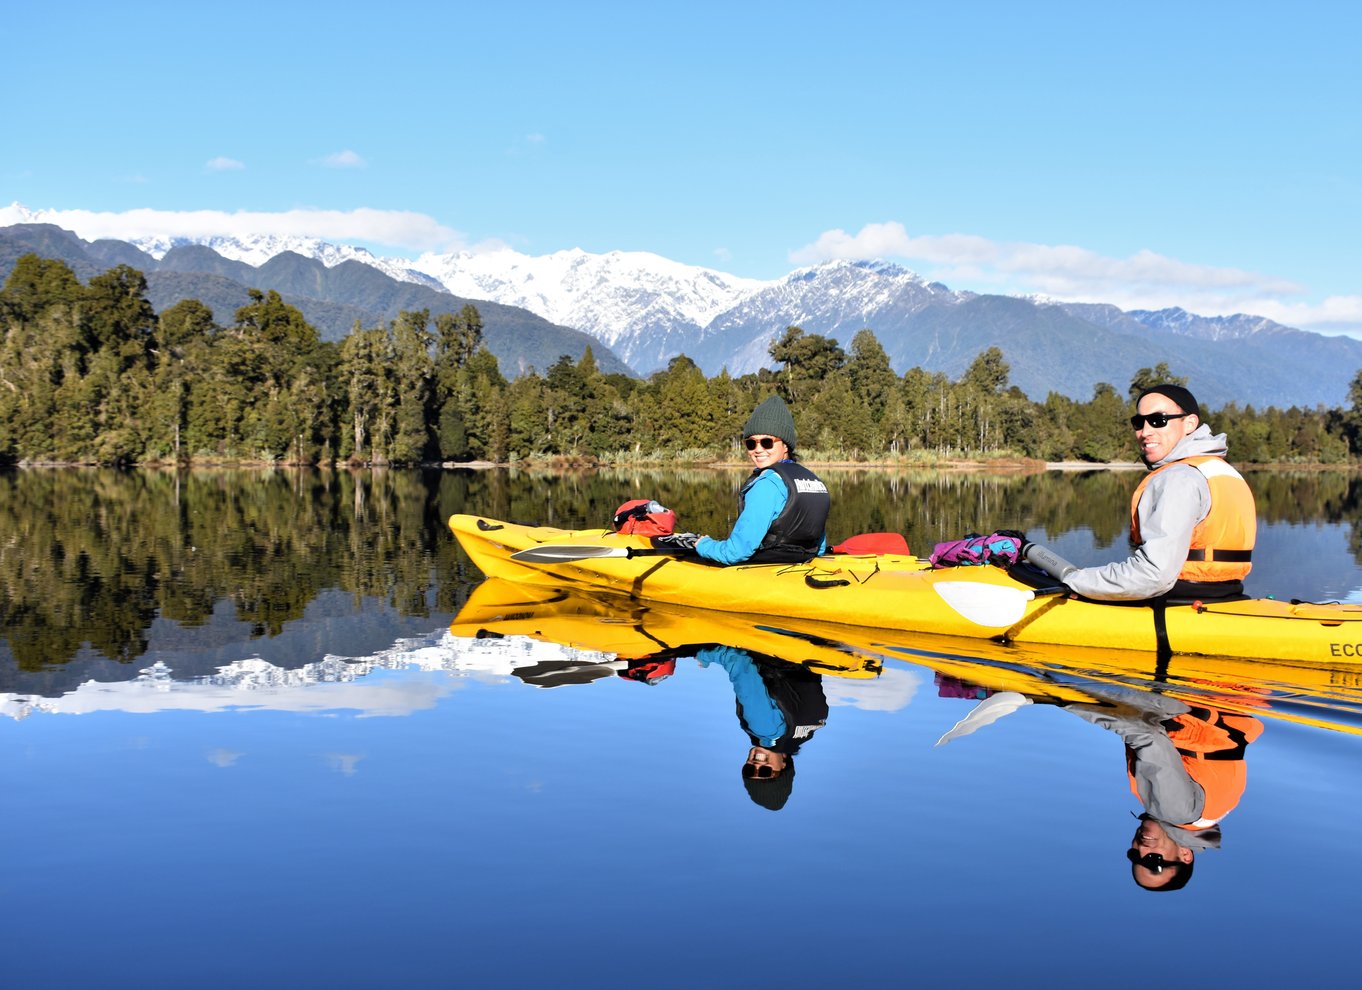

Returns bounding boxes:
[0,204,1362,407]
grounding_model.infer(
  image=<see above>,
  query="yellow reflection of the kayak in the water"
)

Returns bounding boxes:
[449,579,1362,733]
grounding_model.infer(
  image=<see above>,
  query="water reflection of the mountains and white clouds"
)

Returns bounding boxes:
[0,592,921,719]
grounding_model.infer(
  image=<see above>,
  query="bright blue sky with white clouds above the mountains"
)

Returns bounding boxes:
[8,0,1362,336]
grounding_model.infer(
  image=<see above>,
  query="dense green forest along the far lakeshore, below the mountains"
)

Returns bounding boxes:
[8,255,1362,464]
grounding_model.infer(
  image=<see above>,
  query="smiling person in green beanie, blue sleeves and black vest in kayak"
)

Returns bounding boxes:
[652,395,829,564]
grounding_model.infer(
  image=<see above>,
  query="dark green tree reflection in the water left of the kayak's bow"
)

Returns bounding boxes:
[0,471,479,670]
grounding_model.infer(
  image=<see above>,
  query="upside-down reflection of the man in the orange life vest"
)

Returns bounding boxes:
[1064,686,1263,891]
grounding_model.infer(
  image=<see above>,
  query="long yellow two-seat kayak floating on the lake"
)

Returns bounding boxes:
[449,515,1362,667]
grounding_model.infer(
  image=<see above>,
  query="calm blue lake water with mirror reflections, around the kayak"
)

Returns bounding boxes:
[0,470,1362,990]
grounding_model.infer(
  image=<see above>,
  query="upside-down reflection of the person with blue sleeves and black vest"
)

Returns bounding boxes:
[695,645,828,812]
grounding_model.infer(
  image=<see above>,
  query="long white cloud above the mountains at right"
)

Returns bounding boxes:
[790,221,1362,332]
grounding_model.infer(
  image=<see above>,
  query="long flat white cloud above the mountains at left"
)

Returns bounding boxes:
[8,204,467,251]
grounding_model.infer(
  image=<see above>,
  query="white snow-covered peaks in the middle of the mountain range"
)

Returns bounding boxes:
[129,236,972,374]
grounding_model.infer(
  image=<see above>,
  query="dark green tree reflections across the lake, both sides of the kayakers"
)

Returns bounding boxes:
[8,468,1362,670]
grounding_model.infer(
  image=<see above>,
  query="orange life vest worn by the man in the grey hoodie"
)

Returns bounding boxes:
[1130,455,1258,581]
